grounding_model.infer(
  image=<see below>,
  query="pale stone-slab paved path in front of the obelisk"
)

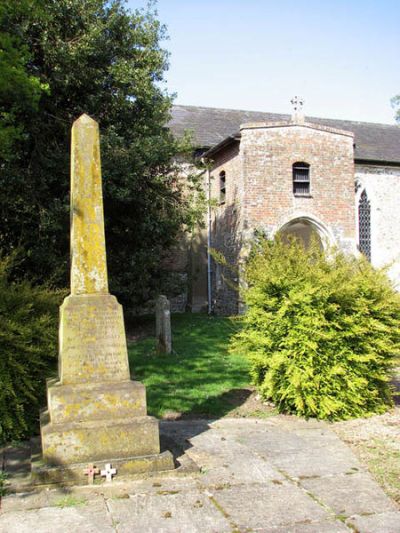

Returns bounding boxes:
[0,416,400,533]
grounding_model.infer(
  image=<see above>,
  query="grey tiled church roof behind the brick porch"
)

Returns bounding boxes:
[169,105,400,165]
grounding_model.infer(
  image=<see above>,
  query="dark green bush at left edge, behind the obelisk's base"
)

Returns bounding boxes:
[0,260,61,442]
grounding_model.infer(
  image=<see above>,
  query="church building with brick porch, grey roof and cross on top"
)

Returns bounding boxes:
[170,102,400,314]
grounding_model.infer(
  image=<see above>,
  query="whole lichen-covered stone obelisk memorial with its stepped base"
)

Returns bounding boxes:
[32,115,173,483]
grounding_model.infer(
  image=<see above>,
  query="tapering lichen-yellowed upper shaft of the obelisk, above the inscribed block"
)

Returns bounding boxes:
[71,114,108,295]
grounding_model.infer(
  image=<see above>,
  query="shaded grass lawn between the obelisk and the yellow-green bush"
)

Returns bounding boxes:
[128,313,251,417]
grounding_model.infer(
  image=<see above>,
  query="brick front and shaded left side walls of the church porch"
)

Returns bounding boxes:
[211,118,356,314]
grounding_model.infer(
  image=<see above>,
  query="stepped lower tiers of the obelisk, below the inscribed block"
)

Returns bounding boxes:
[36,374,174,478]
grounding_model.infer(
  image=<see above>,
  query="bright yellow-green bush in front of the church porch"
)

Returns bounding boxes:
[233,239,400,420]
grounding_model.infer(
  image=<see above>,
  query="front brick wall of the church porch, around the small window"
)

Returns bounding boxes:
[240,123,355,251]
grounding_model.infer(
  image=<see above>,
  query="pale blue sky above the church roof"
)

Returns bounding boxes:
[128,0,400,124]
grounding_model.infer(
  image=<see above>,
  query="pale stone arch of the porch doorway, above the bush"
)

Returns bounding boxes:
[274,216,334,250]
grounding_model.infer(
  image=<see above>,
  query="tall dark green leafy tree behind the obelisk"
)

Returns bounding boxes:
[0,0,201,306]
